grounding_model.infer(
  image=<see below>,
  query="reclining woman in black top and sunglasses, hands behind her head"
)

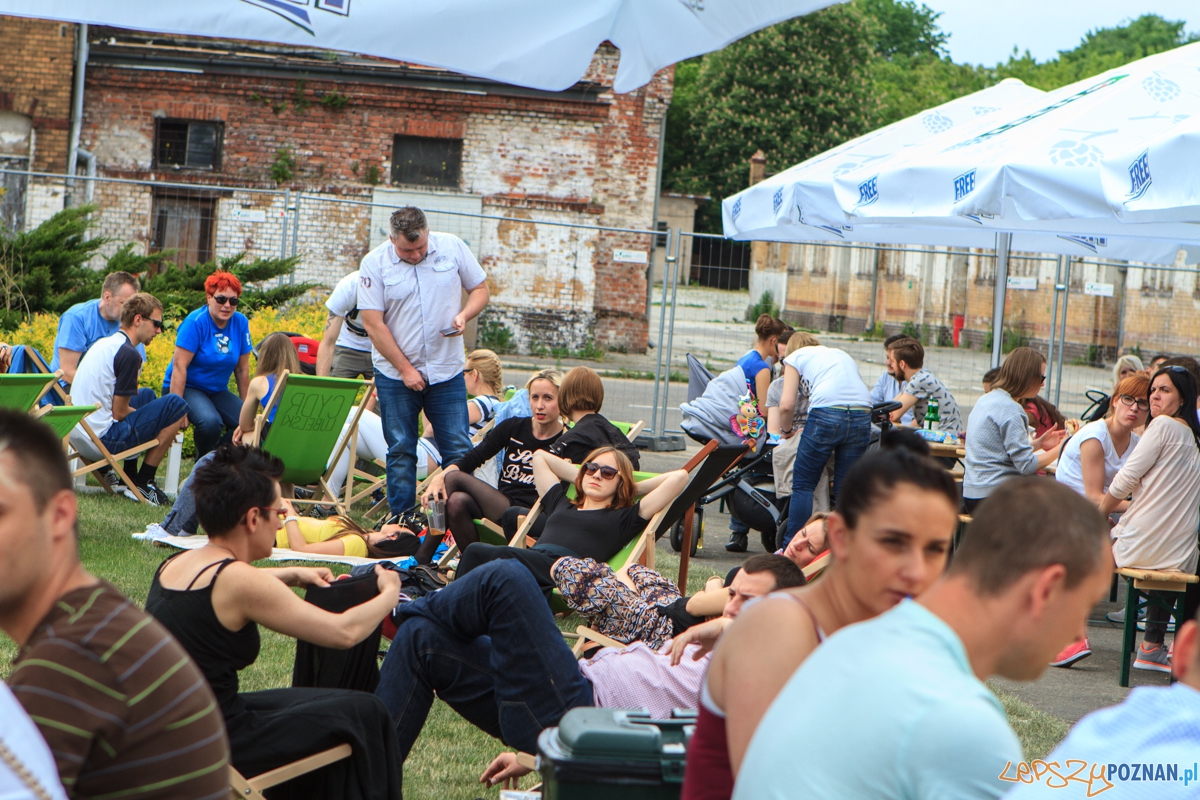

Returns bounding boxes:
[458,446,688,599]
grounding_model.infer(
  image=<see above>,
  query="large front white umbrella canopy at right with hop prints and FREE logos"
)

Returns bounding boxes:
[835,44,1200,230]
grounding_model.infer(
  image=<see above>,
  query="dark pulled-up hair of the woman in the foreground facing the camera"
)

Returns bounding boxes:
[838,424,955,529]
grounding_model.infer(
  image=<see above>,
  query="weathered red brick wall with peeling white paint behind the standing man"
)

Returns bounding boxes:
[75,38,673,351]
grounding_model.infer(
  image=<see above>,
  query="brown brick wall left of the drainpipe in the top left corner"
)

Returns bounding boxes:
[0,17,76,173]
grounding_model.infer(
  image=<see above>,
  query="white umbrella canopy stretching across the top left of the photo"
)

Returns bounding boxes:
[0,0,841,92]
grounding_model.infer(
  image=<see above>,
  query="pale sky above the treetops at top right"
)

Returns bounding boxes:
[917,0,1200,66]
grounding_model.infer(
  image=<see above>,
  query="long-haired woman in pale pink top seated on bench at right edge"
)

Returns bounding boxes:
[1100,366,1200,673]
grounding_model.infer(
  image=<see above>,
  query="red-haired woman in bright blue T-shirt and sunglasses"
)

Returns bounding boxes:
[162,271,253,458]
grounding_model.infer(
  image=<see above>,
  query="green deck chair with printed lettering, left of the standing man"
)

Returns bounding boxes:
[252,371,370,515]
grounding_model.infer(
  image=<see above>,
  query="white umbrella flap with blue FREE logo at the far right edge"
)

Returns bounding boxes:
[1100,114,1200,223]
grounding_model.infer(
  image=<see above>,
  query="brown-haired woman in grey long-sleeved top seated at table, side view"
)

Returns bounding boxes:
[962,347,1066,513]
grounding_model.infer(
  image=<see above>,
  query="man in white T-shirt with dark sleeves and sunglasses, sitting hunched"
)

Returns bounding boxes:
[71,293,187,505]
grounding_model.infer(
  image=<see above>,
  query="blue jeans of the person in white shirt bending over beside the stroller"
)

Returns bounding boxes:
[784,408,871,547]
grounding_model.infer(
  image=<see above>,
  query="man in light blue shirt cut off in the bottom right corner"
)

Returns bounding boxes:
[1006,606,1200,800]
